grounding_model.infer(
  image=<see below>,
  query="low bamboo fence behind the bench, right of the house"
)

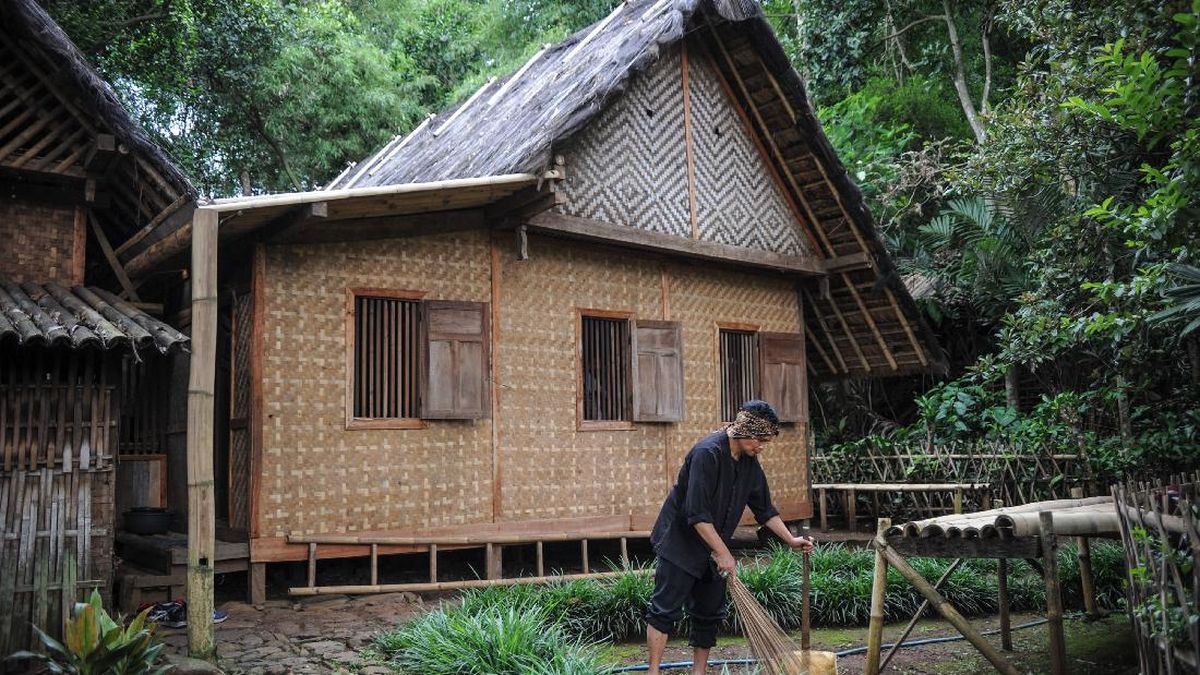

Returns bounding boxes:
[812,442,1094,521]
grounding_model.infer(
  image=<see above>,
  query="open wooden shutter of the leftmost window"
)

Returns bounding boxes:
[421,300,491,419]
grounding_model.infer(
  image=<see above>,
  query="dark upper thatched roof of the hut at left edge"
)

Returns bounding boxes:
[0,0,197,266]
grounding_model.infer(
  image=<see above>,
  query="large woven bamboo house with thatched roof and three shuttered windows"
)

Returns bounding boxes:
[143,0,938,598]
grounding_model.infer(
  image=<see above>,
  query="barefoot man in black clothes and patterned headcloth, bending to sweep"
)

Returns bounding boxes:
[646,400,812,675]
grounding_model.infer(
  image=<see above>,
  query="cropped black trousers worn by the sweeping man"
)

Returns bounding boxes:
[646,557,726,649]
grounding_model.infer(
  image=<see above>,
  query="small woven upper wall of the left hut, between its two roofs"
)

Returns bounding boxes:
[0,201,84,287]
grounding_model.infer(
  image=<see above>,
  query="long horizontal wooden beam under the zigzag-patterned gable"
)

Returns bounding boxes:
[528,213,824,275]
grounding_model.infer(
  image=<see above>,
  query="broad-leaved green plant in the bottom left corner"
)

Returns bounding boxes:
[13,591,172,675]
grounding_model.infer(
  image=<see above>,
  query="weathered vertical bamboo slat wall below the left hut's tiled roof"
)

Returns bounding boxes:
[0,384,116,655]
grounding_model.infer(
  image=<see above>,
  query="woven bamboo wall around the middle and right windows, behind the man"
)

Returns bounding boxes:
[499,238,808,520]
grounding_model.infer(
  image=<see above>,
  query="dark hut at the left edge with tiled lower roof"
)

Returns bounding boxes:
[0,0,194,653]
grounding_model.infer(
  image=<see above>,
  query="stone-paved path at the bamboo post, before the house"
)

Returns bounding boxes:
[161,593,424,675]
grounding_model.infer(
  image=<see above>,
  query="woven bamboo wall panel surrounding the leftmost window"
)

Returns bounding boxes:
[260,232,492,537]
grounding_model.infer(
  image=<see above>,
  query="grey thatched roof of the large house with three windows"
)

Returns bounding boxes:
[326,0,944,378]
